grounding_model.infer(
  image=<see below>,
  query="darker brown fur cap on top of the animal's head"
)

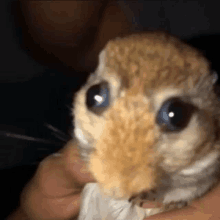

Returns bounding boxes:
[105,32,209,90]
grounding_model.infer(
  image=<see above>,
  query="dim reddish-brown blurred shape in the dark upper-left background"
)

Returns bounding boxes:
[20,0,131,74]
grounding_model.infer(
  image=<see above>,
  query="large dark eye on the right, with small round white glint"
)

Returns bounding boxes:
[156,98,194,131]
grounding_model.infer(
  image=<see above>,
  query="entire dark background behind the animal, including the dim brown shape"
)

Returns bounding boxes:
[0,0,220,219]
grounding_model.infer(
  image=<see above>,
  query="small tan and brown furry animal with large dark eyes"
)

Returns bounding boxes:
[73,31,220,217]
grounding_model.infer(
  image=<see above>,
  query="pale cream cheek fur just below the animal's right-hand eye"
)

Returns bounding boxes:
[157,115,214,173]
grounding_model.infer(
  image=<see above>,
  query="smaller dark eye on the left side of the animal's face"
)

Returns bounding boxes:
[86,82,109,114]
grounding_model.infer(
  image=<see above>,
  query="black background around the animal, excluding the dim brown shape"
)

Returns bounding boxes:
[0,0,220,219]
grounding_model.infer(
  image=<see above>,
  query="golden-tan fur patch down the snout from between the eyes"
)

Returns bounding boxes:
[90,95,162,198]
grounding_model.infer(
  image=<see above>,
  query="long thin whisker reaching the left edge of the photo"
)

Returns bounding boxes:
[0,131,62,146]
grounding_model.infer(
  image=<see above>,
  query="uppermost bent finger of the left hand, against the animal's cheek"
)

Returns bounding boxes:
[31,141,94,197]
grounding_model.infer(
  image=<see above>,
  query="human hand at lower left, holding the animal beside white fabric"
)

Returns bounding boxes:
[8,141,94,220]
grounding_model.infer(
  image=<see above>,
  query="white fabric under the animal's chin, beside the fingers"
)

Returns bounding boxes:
[78,183,156,220]
